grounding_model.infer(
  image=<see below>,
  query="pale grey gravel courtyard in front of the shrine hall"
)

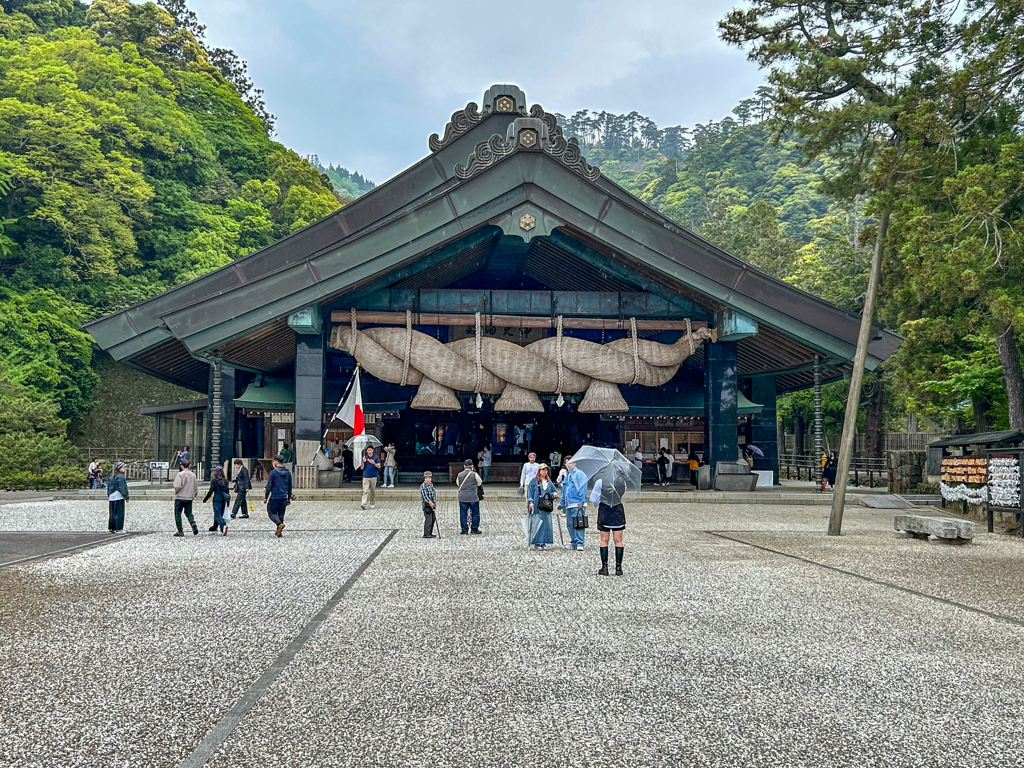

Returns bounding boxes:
[0,500,1024,768]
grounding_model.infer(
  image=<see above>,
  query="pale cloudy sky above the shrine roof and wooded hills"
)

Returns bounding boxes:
[189,0,762,183]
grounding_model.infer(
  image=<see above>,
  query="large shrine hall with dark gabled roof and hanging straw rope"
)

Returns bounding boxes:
[85,84,900,512]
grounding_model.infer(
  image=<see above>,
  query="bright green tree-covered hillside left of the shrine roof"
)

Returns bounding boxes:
[0,0,345,481]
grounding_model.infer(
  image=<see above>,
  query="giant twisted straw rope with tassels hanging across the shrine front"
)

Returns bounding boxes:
[331,310,714,413]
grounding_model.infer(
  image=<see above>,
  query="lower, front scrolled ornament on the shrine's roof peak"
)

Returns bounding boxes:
[454,104,601,181]
